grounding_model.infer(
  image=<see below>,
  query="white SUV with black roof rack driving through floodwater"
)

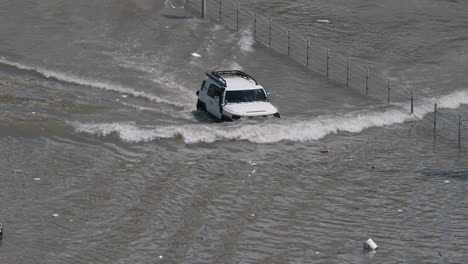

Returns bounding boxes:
[197,71,280,121]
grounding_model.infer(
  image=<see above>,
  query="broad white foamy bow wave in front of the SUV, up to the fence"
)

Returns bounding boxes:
[66,105,414,144]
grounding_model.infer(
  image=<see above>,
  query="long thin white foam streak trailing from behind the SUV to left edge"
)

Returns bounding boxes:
[0,58,184,107]
